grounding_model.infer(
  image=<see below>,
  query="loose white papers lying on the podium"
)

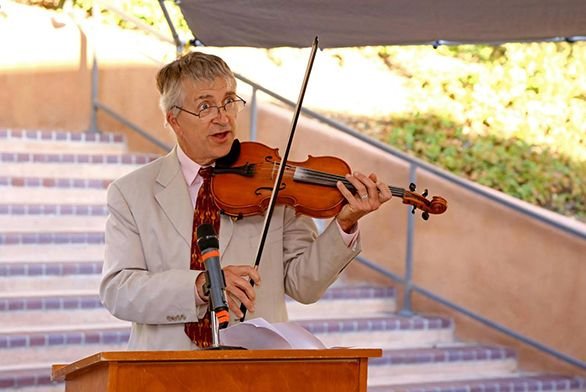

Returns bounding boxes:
[220,318,326,350]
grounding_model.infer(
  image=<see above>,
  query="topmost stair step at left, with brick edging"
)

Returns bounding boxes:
[0,128,127,154]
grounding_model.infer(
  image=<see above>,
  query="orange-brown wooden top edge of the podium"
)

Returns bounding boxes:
[52,348,382,380]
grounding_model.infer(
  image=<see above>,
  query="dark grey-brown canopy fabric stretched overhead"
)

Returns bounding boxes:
[180,0,586,48]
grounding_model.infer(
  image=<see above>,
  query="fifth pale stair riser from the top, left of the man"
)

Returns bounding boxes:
[0,243,104,265]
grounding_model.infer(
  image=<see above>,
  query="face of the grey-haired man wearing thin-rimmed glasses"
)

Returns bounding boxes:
[167,77,237,165]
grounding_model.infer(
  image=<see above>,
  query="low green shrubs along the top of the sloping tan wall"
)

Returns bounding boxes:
[338,112,586,221]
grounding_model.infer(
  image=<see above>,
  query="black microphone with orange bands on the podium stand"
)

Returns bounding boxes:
[197,223,230,328]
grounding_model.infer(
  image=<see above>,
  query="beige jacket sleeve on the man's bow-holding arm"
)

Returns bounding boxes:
[100,182,205,324]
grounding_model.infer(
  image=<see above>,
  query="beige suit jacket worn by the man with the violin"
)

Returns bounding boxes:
[100,149,359,350]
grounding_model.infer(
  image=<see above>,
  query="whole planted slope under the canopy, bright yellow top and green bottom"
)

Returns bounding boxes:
[345,42,586,221]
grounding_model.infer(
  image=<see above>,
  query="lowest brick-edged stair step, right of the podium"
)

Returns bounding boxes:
[368,374,586,392]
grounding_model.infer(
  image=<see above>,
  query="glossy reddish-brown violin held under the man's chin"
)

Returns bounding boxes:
[211,139,448,220]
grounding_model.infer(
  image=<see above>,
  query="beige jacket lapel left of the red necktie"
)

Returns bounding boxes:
[155,147,193,246]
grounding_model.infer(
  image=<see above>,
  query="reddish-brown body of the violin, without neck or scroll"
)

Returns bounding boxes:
[211,142,350,218]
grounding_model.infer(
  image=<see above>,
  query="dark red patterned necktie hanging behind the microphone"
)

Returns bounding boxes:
[185,167,220,348]
